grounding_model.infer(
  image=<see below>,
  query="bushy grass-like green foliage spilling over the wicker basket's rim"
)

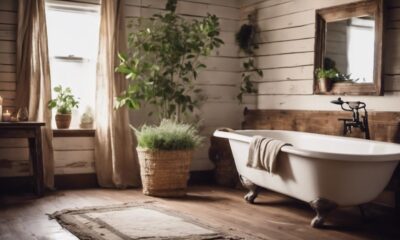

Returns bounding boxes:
[134,119,202,150]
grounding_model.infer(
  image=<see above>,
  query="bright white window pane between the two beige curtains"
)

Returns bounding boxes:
[46,0,100,128]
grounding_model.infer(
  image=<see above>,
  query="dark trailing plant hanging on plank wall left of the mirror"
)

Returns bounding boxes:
[235,14,263,103]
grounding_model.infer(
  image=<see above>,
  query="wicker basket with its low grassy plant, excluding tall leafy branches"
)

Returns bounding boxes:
[135,119,202,197]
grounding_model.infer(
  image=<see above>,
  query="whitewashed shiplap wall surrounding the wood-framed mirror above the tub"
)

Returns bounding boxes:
[241,0,400,111]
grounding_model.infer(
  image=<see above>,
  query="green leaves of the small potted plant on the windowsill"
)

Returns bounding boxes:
[47,85,79,114]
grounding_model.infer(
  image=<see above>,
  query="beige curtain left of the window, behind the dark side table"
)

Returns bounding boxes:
[16,0,54,188]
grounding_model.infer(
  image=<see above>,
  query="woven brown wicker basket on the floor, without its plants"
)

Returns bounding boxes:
[137,148,193,197]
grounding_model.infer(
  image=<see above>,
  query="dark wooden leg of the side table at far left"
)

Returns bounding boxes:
[28,128,44,197]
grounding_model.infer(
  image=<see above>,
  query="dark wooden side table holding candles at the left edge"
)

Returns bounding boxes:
[0,122,45,197]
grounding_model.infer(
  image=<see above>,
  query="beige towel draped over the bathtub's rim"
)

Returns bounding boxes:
[247,136,290,173]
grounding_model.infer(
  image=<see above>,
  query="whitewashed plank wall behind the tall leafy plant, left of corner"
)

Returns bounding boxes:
[125,0,247,170]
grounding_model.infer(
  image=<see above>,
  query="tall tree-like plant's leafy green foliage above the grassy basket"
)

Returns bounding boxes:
[115,0,223,121]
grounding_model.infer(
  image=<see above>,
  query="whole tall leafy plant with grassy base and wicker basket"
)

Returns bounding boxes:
[115,0,223,197]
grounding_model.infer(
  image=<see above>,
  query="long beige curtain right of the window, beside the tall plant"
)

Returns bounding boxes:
[95,0,140,188]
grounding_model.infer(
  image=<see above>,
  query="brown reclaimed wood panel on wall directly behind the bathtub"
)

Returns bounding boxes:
[242,110,400,143]
